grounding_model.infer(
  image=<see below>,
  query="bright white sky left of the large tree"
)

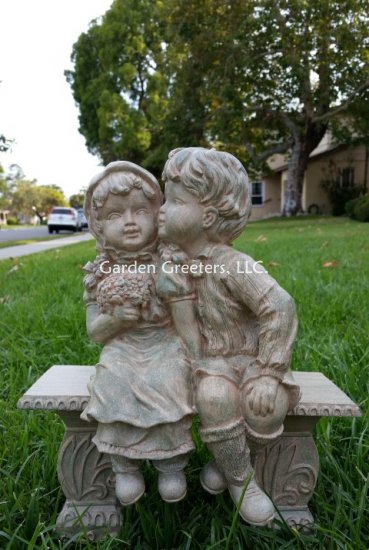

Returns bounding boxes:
[0,0,112,198]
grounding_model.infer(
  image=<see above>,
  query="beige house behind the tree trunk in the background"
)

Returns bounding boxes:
[250,133,369,220]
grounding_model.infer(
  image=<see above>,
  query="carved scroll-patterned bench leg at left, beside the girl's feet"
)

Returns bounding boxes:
[56,411,121,540]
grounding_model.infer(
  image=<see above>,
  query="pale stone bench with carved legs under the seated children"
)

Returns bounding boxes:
[18,365,361,539]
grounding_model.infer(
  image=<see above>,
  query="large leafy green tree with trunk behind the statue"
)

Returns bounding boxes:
[68,0,369,214]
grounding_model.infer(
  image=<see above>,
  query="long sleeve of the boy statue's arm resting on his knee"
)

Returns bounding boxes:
[224,254,297,380]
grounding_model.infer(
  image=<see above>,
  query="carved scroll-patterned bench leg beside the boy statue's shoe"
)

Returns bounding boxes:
[255,417,319,530]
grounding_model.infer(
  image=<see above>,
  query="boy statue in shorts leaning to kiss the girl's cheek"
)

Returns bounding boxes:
[159,147,299,525]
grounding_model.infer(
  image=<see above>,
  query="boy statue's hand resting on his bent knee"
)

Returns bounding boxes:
[243,376,279,416]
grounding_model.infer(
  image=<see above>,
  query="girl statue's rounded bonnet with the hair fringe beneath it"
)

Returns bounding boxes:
[83,160,163,244]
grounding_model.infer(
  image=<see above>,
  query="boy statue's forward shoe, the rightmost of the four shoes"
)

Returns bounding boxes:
[228,479,274,527]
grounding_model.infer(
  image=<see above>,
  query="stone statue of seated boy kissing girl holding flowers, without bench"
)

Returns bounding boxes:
[81,147,299,525]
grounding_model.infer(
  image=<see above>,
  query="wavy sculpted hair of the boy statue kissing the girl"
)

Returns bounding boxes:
[163,147,251,243]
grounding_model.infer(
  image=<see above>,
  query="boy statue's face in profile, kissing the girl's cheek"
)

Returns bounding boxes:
[159,180,204,246]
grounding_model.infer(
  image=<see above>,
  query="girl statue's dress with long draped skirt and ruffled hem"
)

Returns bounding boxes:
[81,253,194,460]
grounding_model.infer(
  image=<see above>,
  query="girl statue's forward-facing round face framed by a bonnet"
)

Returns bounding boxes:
[98,189,157,252]
